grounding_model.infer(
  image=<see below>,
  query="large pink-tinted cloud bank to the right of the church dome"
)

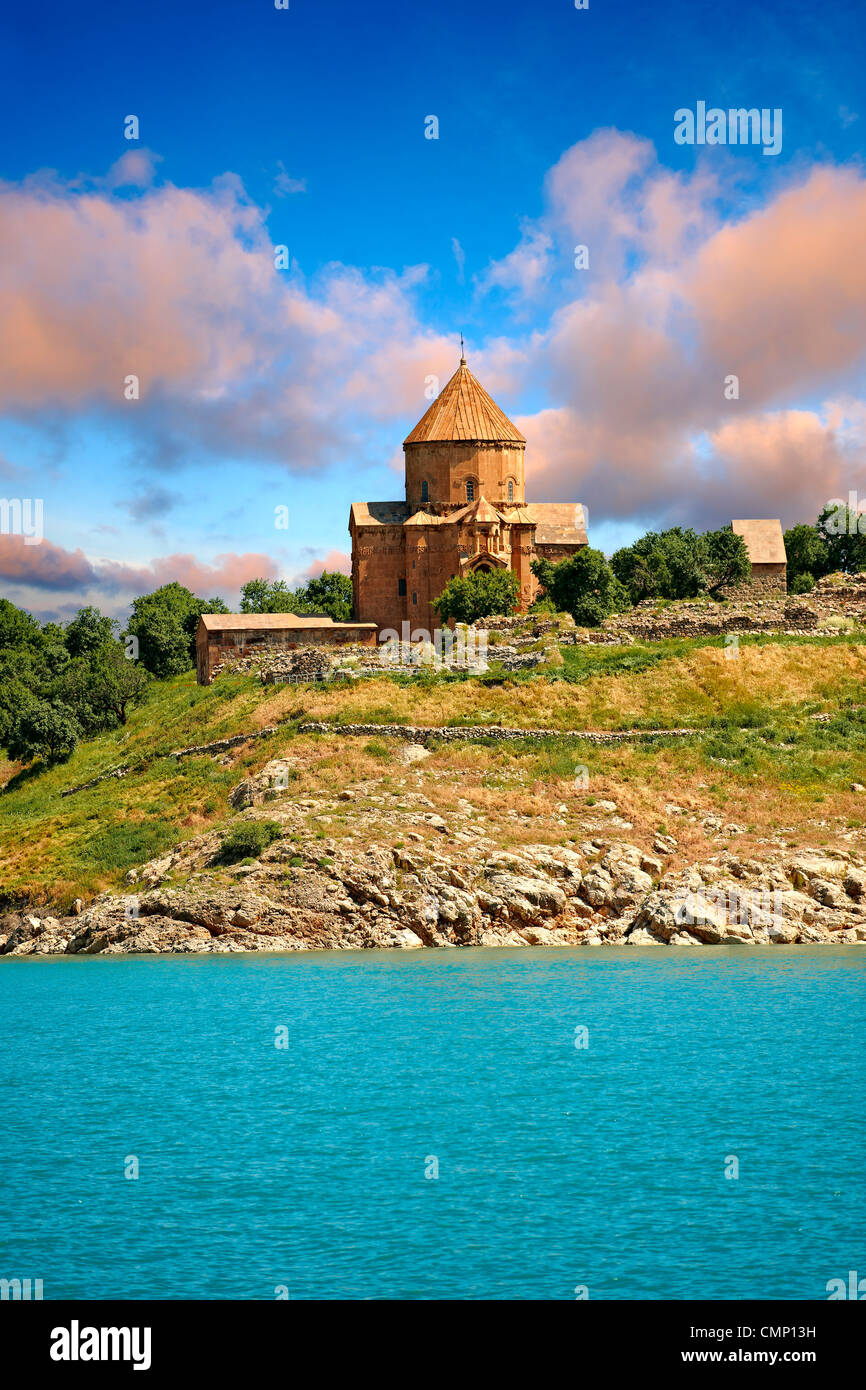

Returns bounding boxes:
[497,132,866,524]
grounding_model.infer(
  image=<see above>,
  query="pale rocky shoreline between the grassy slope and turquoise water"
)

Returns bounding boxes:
[0,815,866,956]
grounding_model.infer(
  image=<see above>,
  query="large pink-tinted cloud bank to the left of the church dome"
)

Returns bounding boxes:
[0,166,445,470]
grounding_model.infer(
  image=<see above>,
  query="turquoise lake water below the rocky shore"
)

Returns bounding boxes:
[0,947,866,1298]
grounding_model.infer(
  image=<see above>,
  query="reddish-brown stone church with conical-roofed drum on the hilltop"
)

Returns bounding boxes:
[349,357,587,632]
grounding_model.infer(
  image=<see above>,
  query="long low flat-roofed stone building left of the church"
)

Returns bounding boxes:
[196,613,377,685]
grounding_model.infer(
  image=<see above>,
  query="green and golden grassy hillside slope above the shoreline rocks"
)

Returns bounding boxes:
[0,638,866,910]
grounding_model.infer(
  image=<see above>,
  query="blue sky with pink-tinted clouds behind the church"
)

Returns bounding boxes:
[0,0,866,616]
